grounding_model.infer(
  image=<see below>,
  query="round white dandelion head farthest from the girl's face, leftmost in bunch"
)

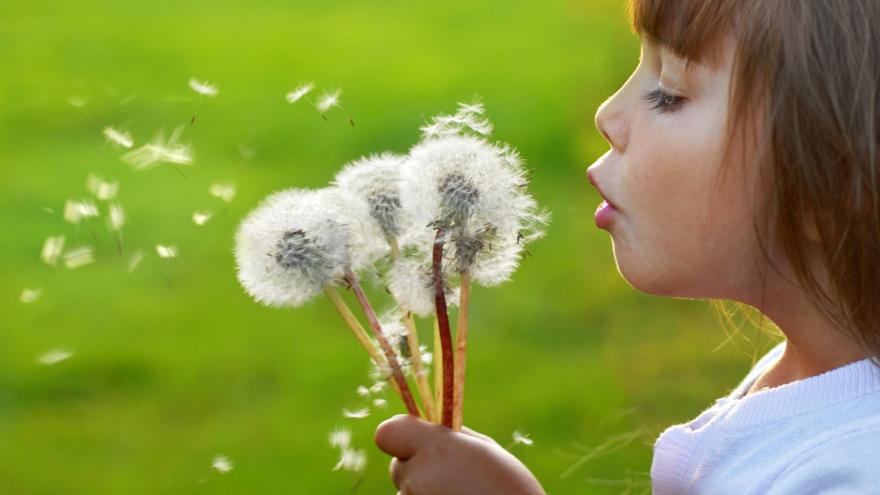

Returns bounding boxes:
[235,188,388,307]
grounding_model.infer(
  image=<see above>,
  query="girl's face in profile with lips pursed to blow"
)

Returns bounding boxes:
[587,38,757,301]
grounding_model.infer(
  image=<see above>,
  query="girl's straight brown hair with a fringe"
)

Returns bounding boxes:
[629,0,880,363]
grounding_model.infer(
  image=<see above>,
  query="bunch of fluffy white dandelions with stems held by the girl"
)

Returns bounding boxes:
[236,105,548,430]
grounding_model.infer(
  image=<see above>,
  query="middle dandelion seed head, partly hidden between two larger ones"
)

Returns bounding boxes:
[333,153,406,239]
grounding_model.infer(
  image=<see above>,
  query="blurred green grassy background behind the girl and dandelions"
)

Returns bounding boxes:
[0,0,784,495]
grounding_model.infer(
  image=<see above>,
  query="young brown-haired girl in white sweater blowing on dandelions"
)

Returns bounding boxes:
[376,0,880,495]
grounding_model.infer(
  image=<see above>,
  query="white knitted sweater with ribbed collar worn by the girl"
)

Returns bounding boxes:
[651,341,880,495]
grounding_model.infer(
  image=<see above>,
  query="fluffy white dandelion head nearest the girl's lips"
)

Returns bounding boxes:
[401,134,547,286]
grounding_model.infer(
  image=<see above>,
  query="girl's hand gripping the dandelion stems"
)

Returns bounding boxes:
[376,414,544,495]
